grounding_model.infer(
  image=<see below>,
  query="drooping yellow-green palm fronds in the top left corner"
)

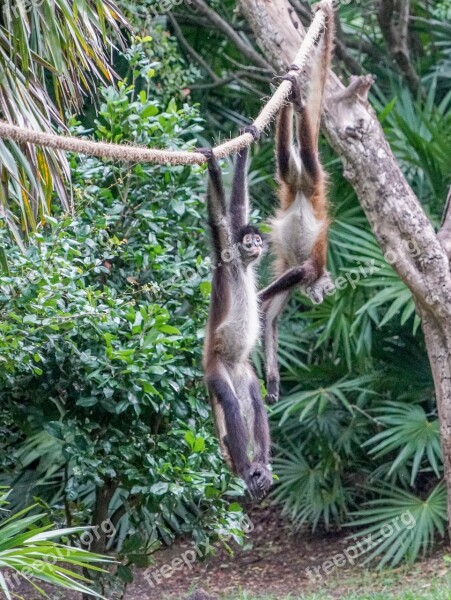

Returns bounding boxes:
[0,0,127,237]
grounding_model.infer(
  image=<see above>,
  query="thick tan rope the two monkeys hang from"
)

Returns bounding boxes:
[0,5,326,165]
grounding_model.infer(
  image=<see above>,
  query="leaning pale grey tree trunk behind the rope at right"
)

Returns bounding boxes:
[240,0,451,537]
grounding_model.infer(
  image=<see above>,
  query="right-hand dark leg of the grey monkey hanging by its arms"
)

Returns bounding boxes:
[249,371,272,498]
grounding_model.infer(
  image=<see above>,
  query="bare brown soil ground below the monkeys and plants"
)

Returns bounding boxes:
[7,506,451,600]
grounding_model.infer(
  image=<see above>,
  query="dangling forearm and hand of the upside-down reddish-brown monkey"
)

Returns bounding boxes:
[262,291,289,404]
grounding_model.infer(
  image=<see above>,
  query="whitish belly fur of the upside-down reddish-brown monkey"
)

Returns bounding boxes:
[271,193,325,267]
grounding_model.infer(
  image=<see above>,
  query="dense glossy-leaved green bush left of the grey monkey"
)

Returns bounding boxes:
[0,45,247,592]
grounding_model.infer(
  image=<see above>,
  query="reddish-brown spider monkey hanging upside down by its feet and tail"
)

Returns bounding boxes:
[259,2,334,404]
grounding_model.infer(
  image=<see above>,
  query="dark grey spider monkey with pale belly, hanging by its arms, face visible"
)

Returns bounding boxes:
[200,132,272,499]
